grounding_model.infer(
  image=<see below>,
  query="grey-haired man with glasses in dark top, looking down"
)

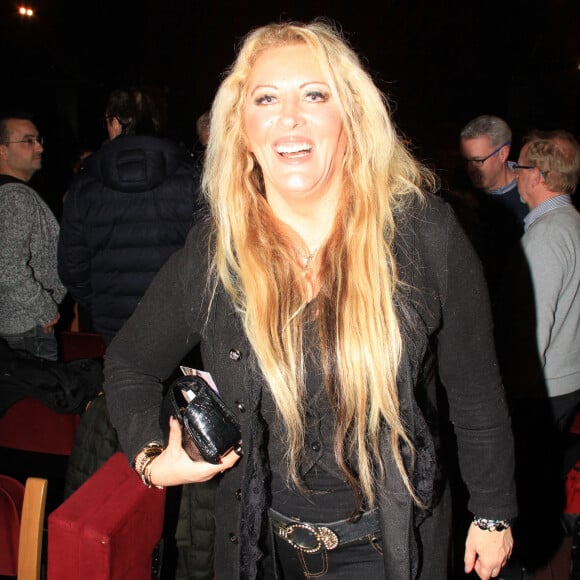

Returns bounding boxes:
[460,115,528,301]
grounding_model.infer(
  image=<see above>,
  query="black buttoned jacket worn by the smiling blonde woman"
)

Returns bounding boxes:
[105,196,516,580]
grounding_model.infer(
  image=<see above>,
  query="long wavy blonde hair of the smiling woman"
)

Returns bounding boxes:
[203,20,431,506]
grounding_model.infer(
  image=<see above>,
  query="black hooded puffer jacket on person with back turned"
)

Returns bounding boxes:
[58,136,200,341]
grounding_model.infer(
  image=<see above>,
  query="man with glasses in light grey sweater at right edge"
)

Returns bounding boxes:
[499,130,580,568]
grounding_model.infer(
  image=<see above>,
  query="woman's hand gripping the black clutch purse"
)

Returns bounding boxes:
[150,417,240,487]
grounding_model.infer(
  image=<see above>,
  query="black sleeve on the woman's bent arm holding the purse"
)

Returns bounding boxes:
[104,229,207,461]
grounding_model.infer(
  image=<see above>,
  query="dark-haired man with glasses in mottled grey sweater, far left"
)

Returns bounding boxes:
[0,116,66,360]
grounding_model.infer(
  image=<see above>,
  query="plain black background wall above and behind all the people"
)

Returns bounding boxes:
[0,0,580,212]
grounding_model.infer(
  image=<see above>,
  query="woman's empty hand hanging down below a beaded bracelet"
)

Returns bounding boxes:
[465,524,514,580]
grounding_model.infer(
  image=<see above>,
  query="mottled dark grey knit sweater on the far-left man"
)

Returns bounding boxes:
[0,182,66,334]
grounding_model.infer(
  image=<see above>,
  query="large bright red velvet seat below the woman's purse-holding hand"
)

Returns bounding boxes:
[48,453,165,580]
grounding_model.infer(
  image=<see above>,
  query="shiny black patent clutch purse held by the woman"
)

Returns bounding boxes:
[160,375,242,465]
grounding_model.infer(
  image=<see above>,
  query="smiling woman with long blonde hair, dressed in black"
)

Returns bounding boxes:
[105,21,515,580]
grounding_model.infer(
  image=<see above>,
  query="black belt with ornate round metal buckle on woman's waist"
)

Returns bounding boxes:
[270,509,380,554]
